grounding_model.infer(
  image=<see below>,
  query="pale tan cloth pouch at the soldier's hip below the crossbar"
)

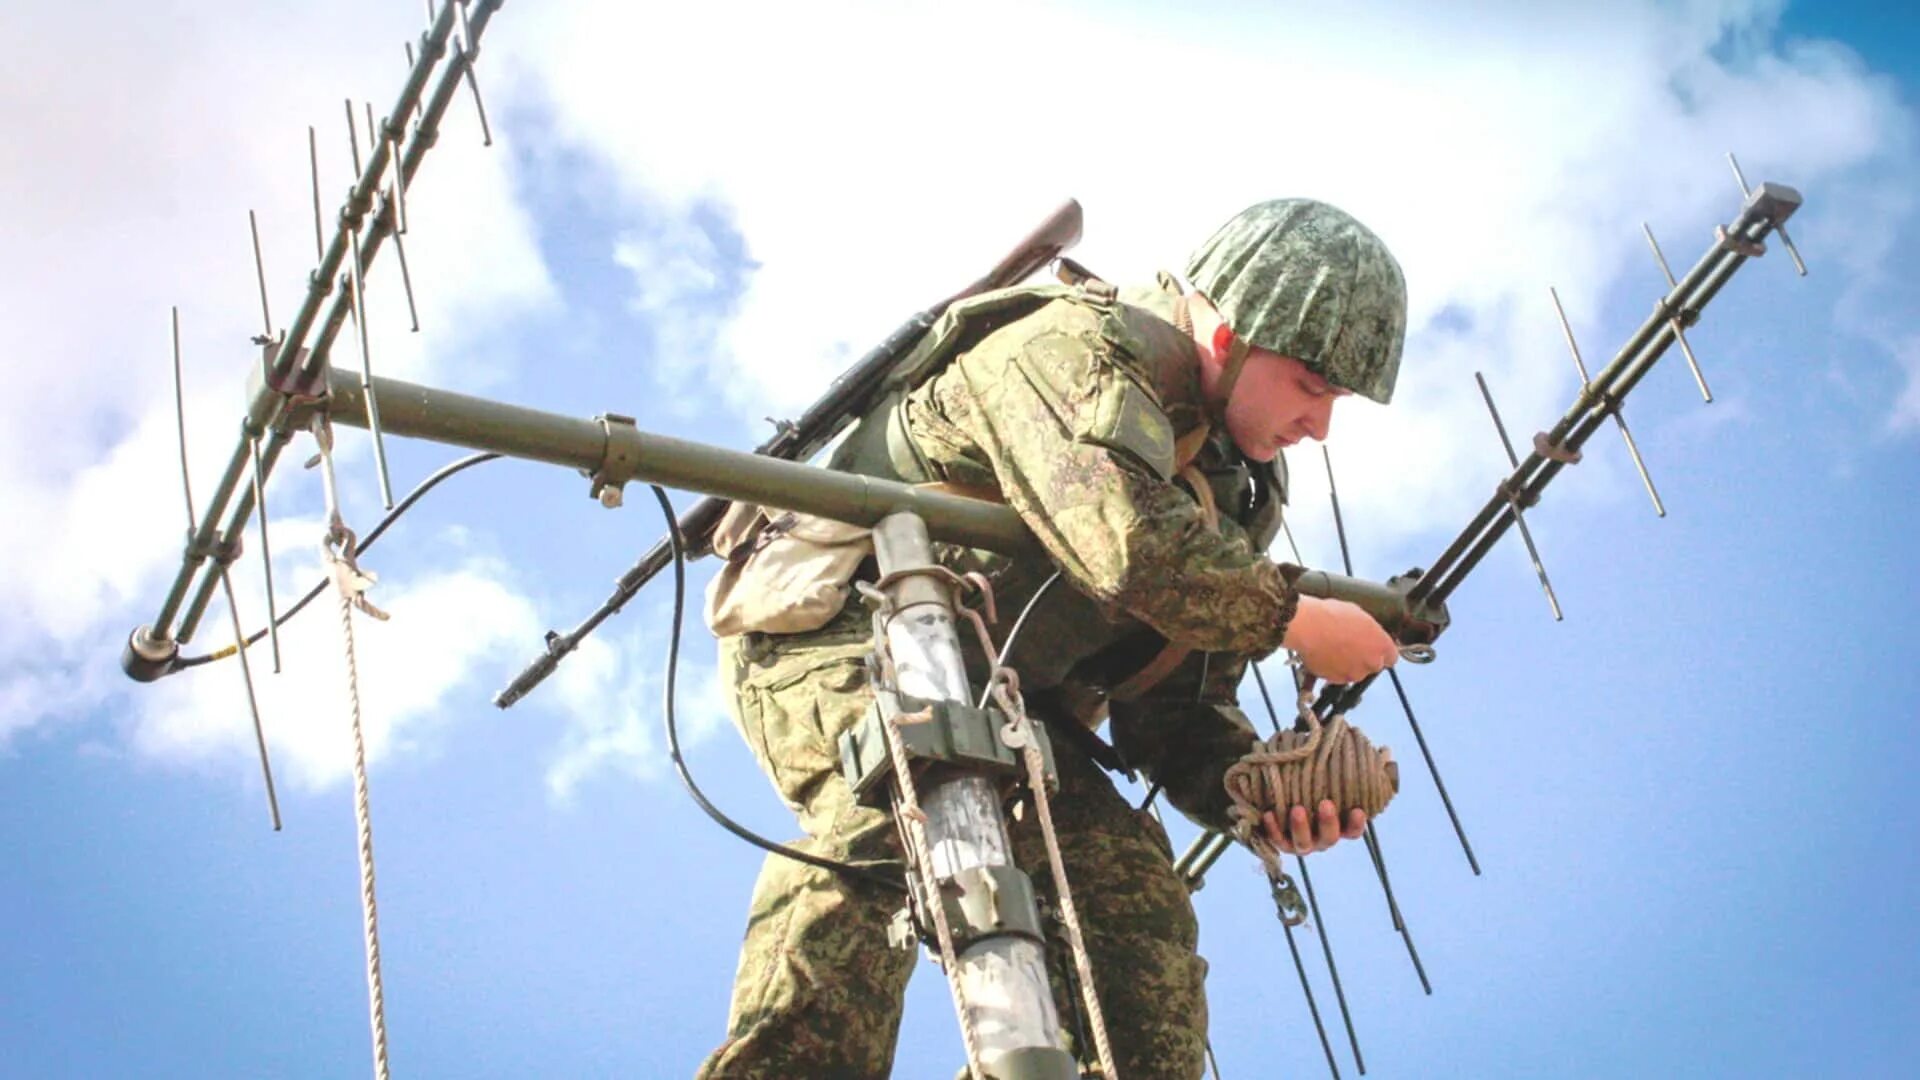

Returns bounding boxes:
[707,503,874,638]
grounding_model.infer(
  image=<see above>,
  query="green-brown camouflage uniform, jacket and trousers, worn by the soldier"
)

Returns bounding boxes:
[701,197,1398,1078]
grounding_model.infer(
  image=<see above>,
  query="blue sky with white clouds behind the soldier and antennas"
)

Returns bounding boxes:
[0,0,1920,1078]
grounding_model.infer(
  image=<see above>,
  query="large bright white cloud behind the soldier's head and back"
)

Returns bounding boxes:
[516,0,1910,561]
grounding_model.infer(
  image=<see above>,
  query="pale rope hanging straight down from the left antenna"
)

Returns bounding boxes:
[313,417,388,1080]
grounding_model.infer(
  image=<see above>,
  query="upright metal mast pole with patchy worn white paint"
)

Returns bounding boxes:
[874,513,1079,1080]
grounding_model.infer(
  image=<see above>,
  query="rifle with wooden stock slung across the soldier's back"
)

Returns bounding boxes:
[493,198,1083,709]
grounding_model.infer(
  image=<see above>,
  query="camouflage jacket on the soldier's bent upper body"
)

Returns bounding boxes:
[833,281,1298,824]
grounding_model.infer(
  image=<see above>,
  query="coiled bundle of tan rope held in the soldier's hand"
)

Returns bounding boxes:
[1223,694,1400,878]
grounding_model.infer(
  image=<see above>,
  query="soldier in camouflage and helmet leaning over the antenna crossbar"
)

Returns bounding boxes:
[701,200,1405,1078]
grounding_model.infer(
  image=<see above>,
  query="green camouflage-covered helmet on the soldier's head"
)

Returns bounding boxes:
[1187,198,1407,405]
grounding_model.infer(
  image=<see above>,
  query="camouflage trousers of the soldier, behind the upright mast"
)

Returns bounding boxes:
[699,621,1206,1080]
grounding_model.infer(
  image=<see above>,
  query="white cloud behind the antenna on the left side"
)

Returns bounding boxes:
[0,0,555,760]
